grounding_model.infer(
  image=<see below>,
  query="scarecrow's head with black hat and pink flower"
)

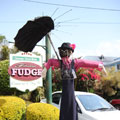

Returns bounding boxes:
[58,43,75,58]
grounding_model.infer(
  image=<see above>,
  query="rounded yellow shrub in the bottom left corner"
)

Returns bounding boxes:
[0,96,26,120]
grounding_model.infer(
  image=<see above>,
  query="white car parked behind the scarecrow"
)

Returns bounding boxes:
[41,91,120,120]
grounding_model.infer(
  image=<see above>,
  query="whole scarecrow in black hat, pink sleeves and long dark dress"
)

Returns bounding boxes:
[42,43,103,120]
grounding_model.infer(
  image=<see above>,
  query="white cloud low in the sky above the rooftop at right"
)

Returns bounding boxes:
[74,40,120,57]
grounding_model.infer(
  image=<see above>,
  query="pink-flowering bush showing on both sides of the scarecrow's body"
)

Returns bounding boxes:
[52,68,101,92]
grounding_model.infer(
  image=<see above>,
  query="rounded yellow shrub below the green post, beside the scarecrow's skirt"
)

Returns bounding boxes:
[26,103,59,120]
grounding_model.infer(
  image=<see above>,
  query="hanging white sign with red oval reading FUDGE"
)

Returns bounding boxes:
[8,52,42,91]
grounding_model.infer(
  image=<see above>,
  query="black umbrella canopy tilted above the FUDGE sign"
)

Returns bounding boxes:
[14,16,54,52]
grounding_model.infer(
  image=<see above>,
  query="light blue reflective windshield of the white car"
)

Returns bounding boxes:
[77,95,113,111]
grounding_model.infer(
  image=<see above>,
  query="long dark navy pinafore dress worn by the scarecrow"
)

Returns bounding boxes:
[60,61,78,120]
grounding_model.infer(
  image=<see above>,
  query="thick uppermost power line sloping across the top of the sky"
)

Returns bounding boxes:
[24,0,120,12]
